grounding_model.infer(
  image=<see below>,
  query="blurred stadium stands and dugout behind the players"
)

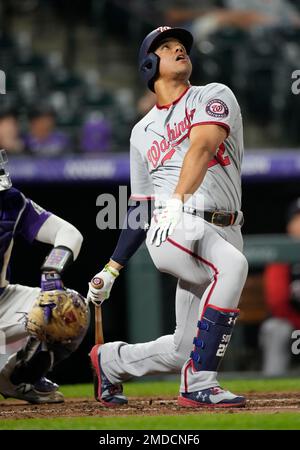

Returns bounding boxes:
[0,0,300,383]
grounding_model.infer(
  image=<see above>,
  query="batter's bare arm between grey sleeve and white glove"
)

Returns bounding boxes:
[173,124,227,202]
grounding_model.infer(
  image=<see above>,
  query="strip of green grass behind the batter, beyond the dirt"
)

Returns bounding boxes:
[60,378,300,397]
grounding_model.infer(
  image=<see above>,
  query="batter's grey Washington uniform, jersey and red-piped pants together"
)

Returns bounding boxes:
[101,83,248,393]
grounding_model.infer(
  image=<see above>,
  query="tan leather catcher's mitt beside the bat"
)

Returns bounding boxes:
[26,289,88,342]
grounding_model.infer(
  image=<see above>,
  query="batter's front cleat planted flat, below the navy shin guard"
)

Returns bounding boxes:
[178,386,246,408]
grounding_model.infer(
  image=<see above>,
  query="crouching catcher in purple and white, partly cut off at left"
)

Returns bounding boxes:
[0,150,89,403]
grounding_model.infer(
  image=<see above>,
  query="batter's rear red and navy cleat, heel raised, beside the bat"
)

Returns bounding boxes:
[89,345,128,408]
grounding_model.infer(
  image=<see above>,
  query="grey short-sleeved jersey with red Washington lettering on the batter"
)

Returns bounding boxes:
[130,83,244,211]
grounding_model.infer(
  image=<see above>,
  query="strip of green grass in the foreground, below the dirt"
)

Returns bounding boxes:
[0,413,300,430]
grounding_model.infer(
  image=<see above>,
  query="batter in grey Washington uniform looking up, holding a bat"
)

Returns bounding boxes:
[88,27,248,408]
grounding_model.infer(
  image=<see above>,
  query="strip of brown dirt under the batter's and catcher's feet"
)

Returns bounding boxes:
[0,392,300,420]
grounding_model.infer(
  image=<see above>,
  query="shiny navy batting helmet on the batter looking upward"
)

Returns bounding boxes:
[139,27,193,92]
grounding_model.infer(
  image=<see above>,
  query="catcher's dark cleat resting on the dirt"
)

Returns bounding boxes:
[0,355,64,404]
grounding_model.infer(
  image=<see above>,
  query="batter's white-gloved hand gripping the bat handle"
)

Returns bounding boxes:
[87,264,119,306]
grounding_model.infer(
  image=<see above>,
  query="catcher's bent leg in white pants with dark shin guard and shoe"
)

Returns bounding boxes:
[0,285,86,403]
